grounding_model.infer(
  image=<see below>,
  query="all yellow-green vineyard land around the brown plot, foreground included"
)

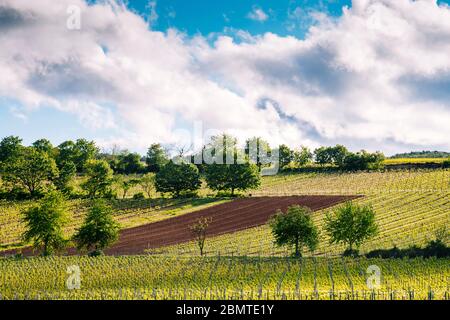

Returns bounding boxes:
[0,170,450,299]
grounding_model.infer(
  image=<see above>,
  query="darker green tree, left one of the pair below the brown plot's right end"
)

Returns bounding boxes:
[270,205,319,257]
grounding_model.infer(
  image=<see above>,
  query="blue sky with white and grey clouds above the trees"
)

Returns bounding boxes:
[0,0,450,154]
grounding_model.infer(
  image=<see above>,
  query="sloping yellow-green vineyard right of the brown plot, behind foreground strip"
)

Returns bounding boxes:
[149,170,450,256]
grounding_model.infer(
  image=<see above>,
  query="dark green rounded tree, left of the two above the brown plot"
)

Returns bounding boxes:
[155,161,201,197]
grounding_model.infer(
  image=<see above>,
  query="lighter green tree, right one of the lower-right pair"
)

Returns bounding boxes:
[325,201,378,255]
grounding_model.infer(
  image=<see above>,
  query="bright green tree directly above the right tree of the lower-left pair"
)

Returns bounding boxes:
[81,160,113,198]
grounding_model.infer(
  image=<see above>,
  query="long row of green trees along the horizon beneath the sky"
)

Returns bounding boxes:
[0,134,384,199]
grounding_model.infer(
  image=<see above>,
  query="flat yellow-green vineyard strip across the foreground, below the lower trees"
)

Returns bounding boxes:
[0,256,450,300]
